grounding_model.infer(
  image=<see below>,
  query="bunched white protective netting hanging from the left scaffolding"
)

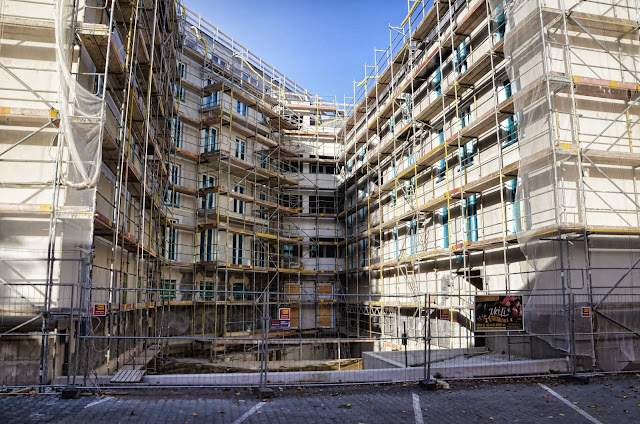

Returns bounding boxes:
[55,0,109,189]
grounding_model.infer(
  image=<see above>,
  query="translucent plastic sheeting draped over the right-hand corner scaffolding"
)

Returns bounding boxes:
[500,0,640,370]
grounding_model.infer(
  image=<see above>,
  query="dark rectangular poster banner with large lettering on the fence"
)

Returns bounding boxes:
[474,295,524,331]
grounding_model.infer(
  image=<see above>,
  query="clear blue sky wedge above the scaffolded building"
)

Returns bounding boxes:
[185,0,407,101]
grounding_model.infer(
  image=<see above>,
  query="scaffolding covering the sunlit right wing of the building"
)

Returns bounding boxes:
[339,0,638,371]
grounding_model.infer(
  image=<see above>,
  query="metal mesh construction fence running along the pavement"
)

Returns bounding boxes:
[2,290,640,388]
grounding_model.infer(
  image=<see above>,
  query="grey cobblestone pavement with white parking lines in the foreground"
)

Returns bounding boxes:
[0,374,640,424]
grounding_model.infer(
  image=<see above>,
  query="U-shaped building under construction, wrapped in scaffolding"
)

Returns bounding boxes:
[0,0,640,385]
